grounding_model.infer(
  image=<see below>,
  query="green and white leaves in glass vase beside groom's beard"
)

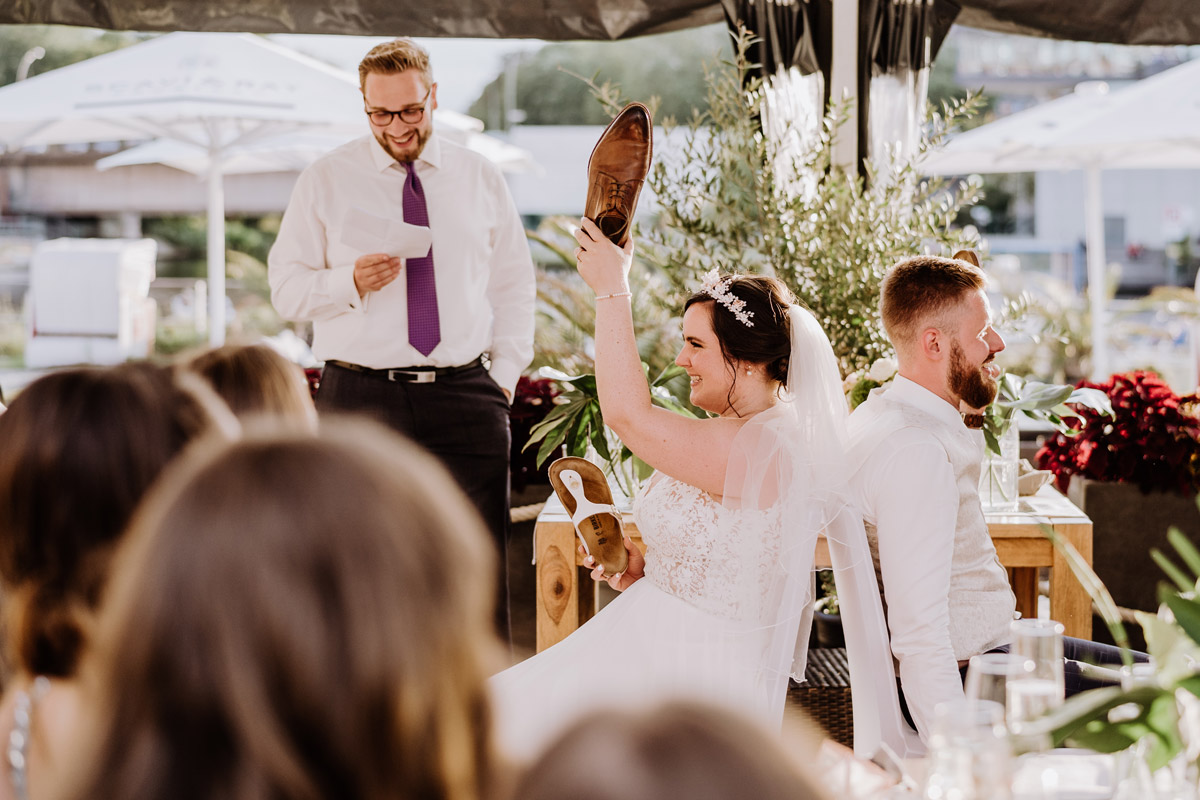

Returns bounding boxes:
[983,372,1112,456]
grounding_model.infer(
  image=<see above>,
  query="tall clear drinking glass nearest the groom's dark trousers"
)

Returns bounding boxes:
[1008,619,1066,732]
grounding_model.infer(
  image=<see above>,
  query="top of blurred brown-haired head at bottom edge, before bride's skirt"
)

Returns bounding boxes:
[512,703,829,800]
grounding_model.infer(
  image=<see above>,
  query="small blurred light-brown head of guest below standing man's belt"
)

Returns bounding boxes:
[184,344,317,429]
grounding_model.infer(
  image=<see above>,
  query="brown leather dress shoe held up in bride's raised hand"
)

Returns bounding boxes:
[583,103,653,247]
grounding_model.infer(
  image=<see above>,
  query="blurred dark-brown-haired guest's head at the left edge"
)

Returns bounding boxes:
[0,363,228,678]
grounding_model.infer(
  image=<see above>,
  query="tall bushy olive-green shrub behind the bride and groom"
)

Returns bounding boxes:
[638,30,979,372]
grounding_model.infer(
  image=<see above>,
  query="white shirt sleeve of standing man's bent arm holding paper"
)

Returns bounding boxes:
[266,169,364,323]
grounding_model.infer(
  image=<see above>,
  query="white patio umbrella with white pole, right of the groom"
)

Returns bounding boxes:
[922,60,1200,378]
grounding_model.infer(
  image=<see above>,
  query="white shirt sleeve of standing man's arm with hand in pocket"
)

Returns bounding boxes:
[487,172,538,396]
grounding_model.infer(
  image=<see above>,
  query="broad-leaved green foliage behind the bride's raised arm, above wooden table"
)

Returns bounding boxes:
[524,363,697,498]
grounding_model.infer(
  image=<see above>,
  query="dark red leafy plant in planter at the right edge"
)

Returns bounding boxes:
[1037,372,1200,646]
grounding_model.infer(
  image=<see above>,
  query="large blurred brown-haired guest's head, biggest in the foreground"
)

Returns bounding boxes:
[52,421,497,800]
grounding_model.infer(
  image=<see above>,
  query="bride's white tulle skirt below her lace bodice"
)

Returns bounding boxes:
[490,578,786,760]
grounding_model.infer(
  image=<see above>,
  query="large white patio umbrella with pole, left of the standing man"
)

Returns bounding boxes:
[0,32,417,344]
